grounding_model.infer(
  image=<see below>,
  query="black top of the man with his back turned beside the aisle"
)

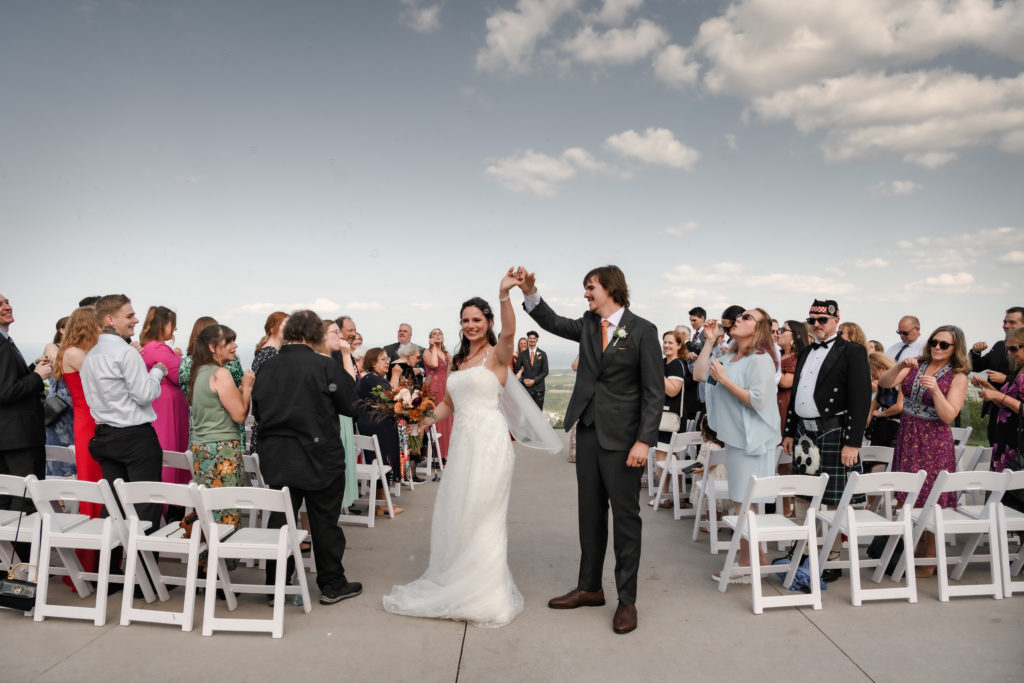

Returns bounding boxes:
[253,344,358,490]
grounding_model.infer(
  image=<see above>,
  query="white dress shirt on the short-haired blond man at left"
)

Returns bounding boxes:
[82,334,164,427]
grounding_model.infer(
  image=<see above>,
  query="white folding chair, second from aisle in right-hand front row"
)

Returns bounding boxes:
[817,470,928,607]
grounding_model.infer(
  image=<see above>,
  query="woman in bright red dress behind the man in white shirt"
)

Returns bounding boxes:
[53,306,103,571]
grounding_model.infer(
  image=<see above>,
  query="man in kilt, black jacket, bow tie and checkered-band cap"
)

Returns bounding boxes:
[782,299,871,581]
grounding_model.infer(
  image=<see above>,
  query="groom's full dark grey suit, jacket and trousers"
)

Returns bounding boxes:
[527,299,665,605]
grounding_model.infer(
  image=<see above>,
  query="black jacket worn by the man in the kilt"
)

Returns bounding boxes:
[785,337,871,449]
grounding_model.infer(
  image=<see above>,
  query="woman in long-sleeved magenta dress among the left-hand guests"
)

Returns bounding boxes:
[139,306,191,483]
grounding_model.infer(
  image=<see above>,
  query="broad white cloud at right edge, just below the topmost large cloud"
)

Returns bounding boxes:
[752,69,1024,168]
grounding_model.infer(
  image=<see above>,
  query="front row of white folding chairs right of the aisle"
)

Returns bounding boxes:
[709,471,1024,614]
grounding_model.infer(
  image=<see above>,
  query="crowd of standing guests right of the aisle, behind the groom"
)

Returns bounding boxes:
[652,299,1024,581]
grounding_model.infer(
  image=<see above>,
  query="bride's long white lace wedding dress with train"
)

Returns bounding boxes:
[384,366,522,628]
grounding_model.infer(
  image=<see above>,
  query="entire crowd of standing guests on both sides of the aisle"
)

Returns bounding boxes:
[0,294,1024,604]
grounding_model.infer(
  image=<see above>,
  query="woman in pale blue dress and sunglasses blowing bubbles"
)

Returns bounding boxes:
[693,308,779,581]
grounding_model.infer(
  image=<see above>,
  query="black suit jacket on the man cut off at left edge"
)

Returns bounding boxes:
[0,336,46,451]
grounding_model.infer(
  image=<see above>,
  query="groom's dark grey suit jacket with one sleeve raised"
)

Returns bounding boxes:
[528,299,663,452]
